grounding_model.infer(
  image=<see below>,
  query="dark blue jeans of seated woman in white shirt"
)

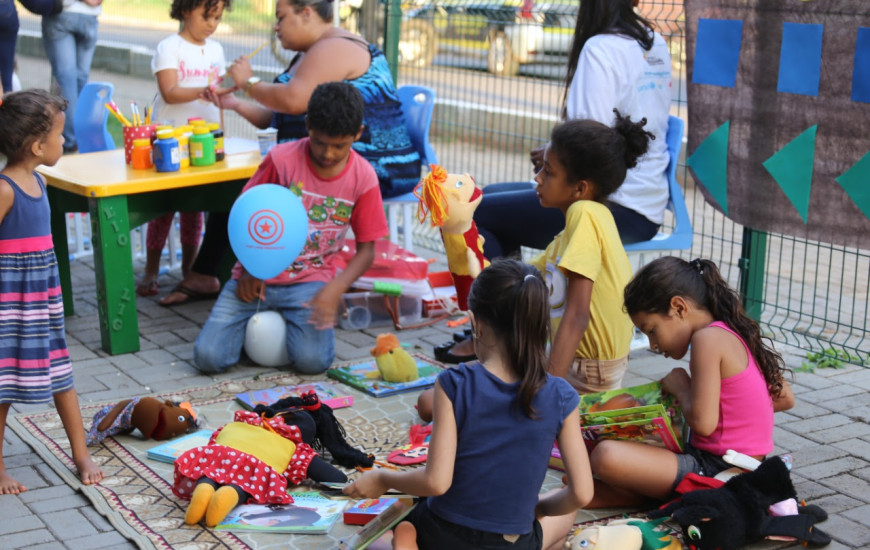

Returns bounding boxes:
[474,181,659,260]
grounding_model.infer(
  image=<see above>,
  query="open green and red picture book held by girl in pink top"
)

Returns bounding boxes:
[579,382,685,452]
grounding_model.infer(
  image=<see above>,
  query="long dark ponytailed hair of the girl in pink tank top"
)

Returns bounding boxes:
[624,256,787,398]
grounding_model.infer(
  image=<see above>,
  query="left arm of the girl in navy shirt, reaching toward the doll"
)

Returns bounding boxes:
[344,380,460,498]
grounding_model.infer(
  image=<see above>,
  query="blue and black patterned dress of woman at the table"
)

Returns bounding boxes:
[272,41,420,198]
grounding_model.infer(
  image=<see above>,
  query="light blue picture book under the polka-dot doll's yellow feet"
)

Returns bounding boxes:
[215,492,347,534]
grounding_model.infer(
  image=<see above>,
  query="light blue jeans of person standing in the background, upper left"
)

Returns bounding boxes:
[42,12,97,149]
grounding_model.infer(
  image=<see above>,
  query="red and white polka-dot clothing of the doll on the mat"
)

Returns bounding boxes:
[172,411,317,504]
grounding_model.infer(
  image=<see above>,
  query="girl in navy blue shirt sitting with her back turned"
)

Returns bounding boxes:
[345,260,592,550]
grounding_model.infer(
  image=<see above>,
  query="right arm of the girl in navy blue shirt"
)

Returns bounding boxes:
[535,409,593,518]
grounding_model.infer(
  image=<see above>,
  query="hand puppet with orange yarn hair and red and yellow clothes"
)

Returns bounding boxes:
[414,164,489,311]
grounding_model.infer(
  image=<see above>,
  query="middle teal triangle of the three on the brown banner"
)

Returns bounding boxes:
[763,124,818,223]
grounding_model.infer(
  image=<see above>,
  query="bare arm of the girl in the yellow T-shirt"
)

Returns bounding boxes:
[549,270,593,378]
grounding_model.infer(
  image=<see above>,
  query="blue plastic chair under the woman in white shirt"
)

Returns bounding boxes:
[625,116,692,254]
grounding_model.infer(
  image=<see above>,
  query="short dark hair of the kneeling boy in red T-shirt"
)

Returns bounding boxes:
[306,82,365,137]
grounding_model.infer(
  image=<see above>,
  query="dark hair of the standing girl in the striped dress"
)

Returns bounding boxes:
[0,89,68,164]
